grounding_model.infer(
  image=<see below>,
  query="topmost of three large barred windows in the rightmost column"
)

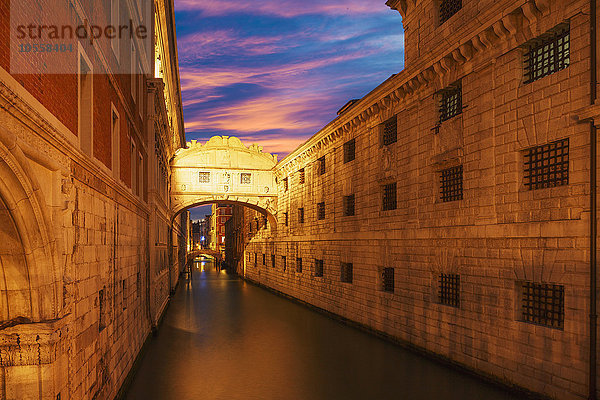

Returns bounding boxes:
[525,24,571,83]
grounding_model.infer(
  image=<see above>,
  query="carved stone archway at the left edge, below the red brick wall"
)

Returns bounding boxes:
[0,135,62,323]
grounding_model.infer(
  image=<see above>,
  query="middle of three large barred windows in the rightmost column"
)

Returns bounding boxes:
[524,138,569,190]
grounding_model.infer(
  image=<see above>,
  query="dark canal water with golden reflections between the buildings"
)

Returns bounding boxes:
[126,261,519,400]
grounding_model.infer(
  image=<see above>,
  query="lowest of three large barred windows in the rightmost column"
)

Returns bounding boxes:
[521,282,565,329]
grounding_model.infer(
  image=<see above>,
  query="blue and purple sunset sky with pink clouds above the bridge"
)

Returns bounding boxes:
[175,0,403,219]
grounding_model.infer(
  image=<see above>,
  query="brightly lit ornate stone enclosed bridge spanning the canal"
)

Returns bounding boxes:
[171,136,277,225]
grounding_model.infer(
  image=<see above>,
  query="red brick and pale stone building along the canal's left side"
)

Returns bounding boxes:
[0,0,187,400]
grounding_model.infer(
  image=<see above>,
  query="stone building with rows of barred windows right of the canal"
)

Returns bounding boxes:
[227,0,600,400]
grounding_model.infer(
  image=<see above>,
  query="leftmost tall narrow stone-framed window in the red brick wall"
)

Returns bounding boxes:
[77,52,94,156]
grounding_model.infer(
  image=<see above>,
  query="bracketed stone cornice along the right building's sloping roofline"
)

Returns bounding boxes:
[277,0,550,176]
